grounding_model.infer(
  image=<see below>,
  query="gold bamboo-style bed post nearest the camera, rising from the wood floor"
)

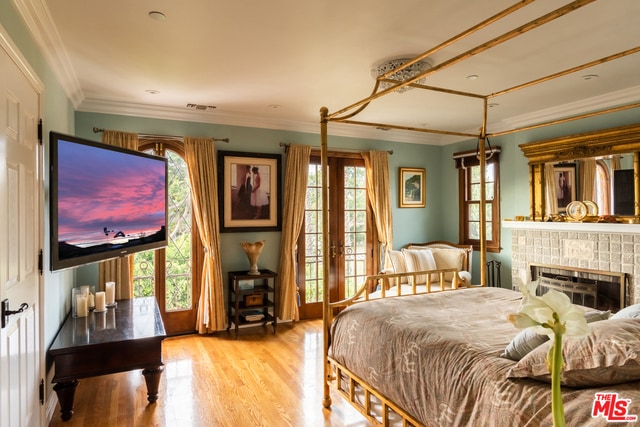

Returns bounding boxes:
[320,107,331,408]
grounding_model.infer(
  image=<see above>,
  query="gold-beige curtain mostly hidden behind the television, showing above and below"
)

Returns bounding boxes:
[98,130,138,299]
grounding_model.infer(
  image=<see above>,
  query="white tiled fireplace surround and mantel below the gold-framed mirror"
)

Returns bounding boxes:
[502,221,640,310]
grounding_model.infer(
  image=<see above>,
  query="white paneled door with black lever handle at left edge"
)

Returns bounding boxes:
[0,28,44,427]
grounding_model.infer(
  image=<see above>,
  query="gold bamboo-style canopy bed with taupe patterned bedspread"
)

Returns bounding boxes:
[320,0,640,426]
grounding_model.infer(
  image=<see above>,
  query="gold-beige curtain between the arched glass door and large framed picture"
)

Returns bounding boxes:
[184,137,226,334]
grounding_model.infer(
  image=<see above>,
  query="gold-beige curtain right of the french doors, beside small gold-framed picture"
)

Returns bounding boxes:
[362,151,393,269]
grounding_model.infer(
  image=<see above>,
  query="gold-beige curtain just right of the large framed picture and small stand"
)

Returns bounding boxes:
[278,144,311,320]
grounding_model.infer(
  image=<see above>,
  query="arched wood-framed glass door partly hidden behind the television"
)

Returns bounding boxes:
[133,141,203,335]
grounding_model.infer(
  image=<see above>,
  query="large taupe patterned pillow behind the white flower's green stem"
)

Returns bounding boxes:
[507,319,640,387]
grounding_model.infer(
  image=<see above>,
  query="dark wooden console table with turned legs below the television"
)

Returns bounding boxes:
[49,297,166,421]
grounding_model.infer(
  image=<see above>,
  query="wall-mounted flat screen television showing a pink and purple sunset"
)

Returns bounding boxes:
[49,132,167,271]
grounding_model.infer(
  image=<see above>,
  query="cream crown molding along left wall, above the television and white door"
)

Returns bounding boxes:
[13,0,84,109]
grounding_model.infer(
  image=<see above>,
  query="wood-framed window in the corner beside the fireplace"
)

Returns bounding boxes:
[454,147,500,252]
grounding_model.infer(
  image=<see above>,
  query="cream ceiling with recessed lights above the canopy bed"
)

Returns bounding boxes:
[14,0,640,144]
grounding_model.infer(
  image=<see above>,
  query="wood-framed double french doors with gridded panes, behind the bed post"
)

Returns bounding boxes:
[297,154,377,319]
